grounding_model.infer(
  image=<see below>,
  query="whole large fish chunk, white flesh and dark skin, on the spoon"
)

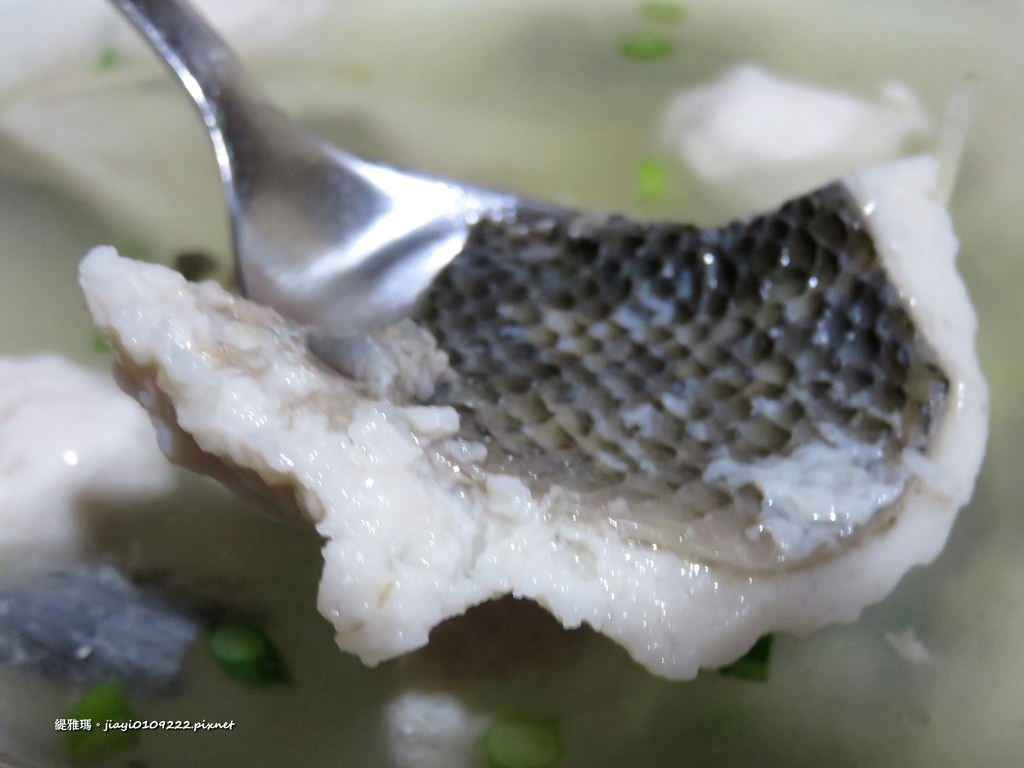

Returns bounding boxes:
[80,157,987,679]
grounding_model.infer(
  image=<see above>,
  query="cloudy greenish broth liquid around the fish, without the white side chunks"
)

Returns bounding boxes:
[0,0,1024,768]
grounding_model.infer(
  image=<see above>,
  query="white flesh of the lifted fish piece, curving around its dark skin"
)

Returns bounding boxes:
[80,157,987,679]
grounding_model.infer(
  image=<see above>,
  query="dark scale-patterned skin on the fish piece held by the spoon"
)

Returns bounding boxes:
[416,183,948,499]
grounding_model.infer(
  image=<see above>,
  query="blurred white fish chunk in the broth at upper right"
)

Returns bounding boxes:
[658,62,931,201]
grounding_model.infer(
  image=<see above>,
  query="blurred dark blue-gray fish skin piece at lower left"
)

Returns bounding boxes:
[0,563,198,690]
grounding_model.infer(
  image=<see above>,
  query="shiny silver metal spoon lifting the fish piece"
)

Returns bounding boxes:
[112,0,546,329]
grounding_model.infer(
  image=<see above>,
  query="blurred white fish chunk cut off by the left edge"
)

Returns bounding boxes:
[0,354,175,566]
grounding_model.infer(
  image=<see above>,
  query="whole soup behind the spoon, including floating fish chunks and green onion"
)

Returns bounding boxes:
[0,0,1024,768]
